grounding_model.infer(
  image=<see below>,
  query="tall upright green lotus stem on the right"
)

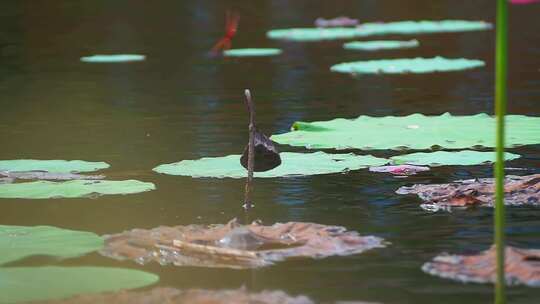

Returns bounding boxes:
[494,0,508,304]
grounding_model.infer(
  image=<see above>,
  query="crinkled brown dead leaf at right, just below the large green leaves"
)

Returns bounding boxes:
[396,174,540,211]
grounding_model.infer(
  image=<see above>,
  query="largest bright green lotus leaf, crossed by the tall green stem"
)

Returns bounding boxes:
[271,113,540,150]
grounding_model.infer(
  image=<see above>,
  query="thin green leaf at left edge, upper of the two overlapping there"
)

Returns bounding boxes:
[0,159,109,173]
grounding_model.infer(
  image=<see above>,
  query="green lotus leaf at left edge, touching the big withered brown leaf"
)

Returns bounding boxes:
[0,225,103,265]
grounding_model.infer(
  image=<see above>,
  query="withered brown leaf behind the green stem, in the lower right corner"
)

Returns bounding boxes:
[422,246,540,287]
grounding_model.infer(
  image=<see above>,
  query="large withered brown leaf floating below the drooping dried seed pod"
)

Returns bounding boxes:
[100,220,386,268]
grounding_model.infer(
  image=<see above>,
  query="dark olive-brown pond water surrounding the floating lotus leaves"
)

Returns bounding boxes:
[0,0,540,303]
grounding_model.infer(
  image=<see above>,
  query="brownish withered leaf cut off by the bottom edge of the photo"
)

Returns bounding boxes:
[35,287,314,304]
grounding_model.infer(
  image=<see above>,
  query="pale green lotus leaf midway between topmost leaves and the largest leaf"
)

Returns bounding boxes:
[330,57,485,74]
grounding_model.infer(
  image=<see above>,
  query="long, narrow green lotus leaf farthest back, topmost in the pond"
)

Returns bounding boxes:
[266,20,491,41]
